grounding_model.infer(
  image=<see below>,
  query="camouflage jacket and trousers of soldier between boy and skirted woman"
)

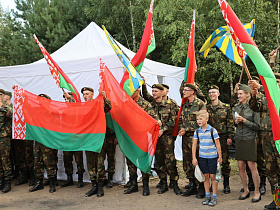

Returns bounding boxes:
[207,101,235,177]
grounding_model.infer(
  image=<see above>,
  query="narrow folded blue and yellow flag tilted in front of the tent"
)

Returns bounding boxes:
[102,26,144,93]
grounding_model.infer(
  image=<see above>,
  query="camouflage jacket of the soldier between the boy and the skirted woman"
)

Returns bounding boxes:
[207,101,235,139]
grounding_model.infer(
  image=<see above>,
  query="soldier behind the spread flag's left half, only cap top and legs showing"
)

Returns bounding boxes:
[29,94,57,193]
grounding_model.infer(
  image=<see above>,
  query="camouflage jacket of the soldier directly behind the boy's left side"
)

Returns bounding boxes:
[179,98,206,134]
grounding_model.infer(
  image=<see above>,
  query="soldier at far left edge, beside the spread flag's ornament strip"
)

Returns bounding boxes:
[0,89,13,193]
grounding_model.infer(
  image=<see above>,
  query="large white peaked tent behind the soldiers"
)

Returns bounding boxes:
[0,22,184,181]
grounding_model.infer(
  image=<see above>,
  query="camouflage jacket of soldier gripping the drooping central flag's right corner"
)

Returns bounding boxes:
[151,99,177,135]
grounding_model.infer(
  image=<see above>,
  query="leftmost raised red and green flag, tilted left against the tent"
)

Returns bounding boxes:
[33,34,81,102]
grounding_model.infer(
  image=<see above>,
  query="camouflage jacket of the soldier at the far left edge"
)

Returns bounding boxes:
[0,103,13,139]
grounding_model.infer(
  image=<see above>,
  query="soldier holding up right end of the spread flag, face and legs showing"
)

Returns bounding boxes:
[81,87,112,197]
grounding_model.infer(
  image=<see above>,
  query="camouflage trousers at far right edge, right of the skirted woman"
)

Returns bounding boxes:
[261,131,280,189]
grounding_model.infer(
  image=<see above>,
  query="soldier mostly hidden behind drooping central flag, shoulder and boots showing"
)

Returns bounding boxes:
[124,88,158,196]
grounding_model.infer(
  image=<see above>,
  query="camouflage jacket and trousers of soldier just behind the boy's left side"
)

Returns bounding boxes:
[179,98,206,179]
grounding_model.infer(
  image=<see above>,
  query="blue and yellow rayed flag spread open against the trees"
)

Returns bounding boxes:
[199,19,255,66]
